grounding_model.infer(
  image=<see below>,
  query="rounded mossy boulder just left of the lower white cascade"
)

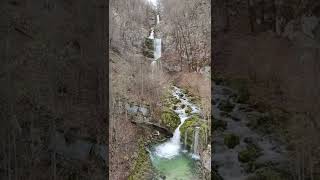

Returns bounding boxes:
[161,109,180,132]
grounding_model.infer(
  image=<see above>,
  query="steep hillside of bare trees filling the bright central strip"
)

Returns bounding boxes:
[109,0,211,179]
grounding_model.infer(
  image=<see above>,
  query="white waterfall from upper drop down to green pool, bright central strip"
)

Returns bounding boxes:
[145,3,200,180]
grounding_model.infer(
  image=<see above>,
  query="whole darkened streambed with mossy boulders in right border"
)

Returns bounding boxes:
[212,82,291,180]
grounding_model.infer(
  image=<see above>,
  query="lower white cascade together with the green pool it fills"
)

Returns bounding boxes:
[150,87,200,180]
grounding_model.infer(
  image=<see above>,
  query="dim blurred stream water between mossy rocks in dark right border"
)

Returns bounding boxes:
[212,84,288,180]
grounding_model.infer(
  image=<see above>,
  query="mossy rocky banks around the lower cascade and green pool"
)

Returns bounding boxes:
[126,86,211,179]
